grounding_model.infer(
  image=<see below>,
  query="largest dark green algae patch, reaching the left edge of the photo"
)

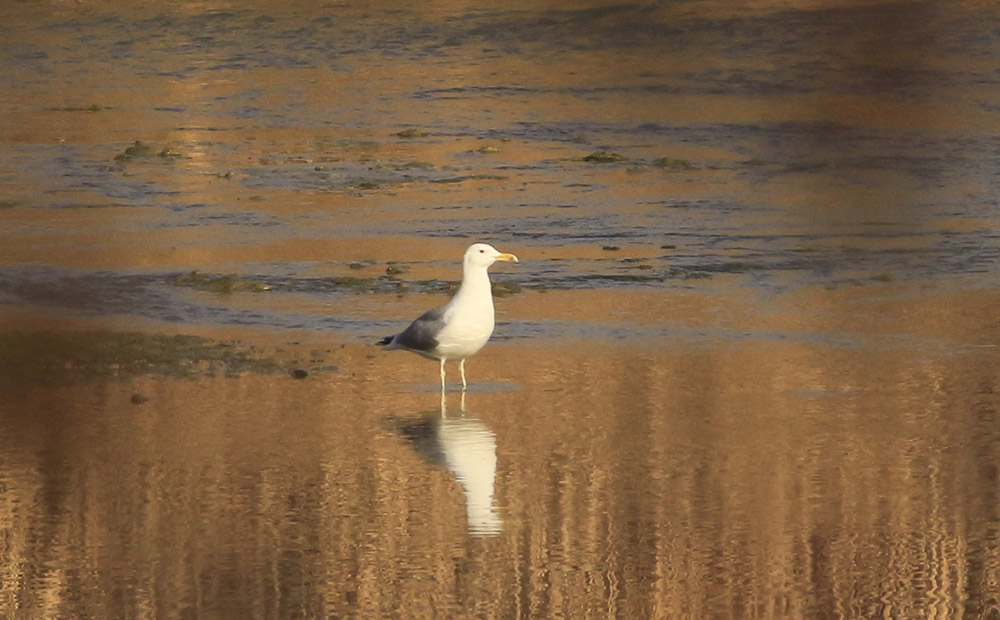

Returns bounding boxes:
[0,331,285,383]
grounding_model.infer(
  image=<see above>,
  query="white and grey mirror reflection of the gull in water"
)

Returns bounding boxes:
[399,392,503,536]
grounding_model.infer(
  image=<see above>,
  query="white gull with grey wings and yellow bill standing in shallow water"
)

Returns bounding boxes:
[377,243,517,392]
